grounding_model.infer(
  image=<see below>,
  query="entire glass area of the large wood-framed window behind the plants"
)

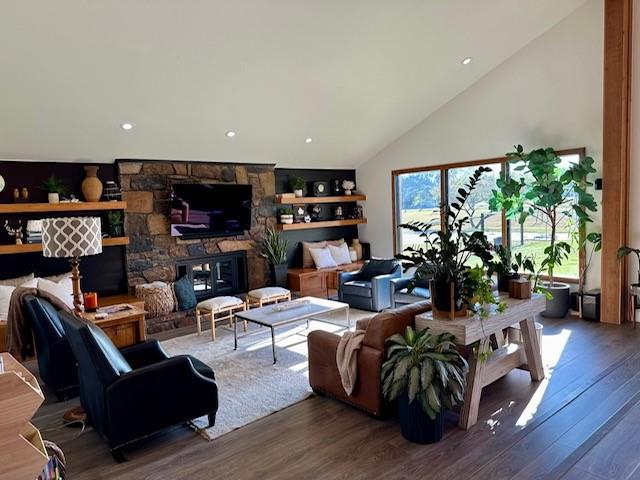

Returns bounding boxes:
[392,149,585,279]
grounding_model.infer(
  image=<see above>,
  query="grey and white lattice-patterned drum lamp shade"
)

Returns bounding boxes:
[42,217,102,258]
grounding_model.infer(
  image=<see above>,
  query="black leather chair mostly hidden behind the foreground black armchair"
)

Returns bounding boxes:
[23,295,78,401]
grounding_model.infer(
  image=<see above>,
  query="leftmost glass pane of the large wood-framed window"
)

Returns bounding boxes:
[394,170,442,251]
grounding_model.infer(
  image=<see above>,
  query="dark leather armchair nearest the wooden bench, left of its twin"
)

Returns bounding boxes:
[338,259,402,312]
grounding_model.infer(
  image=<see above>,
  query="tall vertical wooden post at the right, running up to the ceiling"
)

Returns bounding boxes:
[600,0,633,324]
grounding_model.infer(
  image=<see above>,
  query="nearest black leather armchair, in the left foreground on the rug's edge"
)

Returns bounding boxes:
[60,312,218,462]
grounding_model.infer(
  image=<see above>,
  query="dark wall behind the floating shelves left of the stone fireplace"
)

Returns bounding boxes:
[0,161,127,295]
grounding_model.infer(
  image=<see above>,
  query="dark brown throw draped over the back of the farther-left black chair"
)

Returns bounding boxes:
[7,287,72,360]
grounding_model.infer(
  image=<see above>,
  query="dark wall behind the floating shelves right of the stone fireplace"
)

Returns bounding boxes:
[276,168,366,268]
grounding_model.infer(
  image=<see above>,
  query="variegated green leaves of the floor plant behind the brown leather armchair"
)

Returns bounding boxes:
[382,327,468,420]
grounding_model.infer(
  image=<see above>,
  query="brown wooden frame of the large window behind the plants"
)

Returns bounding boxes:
[391,147,586,284]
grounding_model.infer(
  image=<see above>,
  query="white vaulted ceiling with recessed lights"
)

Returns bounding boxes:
[0,0,584,168]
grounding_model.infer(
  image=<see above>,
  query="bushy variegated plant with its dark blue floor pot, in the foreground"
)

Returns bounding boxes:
[381,327,468,443]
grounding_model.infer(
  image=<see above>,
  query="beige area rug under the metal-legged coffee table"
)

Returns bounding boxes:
[162,308,373,440]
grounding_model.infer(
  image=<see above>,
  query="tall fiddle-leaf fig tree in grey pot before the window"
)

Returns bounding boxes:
[489,145,597,317]
